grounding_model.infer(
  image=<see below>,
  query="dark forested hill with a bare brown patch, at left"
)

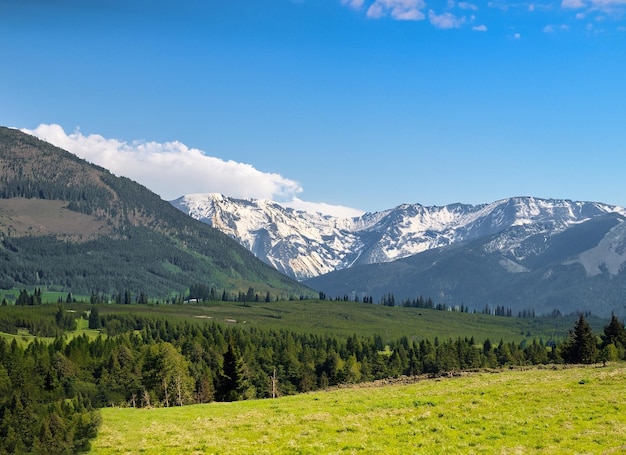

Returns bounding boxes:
[0,127,311,298]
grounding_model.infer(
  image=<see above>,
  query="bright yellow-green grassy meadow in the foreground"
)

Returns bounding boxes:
[91,363,626,454]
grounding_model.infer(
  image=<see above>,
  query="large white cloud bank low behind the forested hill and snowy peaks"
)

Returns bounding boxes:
[22,124,363,216]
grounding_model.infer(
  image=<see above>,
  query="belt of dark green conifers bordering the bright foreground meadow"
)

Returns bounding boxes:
[0,298,626,453]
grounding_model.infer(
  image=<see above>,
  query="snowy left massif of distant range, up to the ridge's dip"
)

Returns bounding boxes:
[172,193,363,280]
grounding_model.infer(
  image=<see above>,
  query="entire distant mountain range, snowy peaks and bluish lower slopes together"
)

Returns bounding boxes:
[172,194,626,313]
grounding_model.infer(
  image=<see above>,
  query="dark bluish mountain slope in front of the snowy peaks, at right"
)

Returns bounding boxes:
[303,210,626,317]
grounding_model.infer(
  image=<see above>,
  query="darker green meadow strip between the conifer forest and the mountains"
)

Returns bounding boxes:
[91,300,596,342]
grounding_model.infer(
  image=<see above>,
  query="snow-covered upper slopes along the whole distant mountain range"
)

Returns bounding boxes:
[172,194,626,280]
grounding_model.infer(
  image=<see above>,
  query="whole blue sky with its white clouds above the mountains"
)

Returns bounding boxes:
[0,0,626,215]
